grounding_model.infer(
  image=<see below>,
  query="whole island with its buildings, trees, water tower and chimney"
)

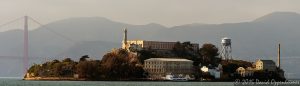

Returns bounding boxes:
[24,28,285,81]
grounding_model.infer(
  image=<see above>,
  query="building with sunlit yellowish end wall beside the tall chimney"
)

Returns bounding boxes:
[255,59,276,71]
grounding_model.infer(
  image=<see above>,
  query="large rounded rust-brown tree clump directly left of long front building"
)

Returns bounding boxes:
[101,49,144,80]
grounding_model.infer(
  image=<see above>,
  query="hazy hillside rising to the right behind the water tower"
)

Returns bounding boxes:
[155,12,300,59]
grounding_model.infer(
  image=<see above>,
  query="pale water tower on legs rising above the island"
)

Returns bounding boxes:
[220,37,232,60]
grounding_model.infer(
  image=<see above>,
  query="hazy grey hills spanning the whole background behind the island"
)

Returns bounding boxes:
[0,12,300,76]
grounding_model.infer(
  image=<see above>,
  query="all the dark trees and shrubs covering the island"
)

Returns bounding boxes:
[25,42,283,81]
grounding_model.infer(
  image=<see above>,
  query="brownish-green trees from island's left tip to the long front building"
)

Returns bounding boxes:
[28,49,146,80]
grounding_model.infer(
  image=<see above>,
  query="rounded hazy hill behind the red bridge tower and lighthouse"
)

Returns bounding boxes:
[0,17,165,57]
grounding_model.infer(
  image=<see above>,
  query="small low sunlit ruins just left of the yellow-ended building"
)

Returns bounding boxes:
[236,67,255,77]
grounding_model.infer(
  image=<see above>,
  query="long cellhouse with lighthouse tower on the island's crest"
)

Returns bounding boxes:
[122,28,199,50]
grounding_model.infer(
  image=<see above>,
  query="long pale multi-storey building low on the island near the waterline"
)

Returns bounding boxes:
[144,58,193,79]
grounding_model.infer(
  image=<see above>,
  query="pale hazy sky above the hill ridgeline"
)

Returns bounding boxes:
[0,0,300,27]
